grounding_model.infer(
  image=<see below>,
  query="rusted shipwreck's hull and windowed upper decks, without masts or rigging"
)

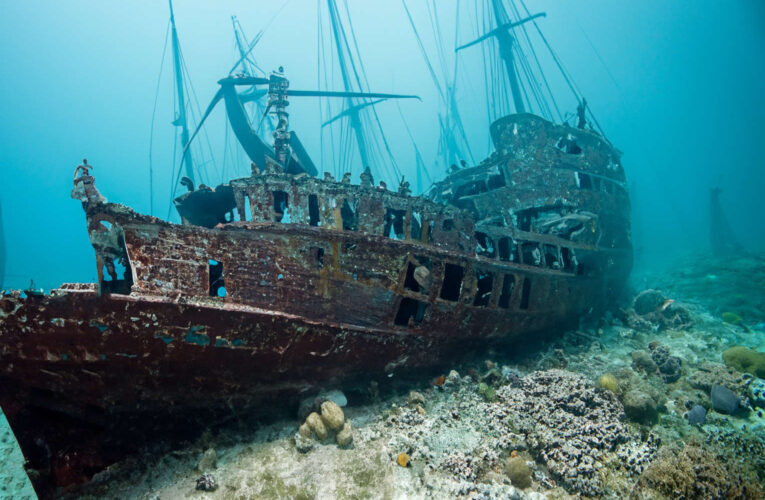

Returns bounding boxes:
[0,115,632,492]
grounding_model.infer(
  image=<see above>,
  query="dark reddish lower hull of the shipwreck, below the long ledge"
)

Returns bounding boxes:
[0,285,572,495]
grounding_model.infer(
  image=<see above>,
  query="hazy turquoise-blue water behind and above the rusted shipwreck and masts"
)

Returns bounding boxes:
[0,0,765,496]
